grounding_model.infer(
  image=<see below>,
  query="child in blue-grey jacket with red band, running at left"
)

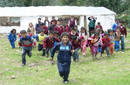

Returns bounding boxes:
[19,30,33,66]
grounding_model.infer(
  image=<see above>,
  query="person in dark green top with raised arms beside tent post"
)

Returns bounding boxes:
[88,16,97,36]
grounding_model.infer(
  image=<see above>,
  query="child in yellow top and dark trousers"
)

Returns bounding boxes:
[36,30,45,56]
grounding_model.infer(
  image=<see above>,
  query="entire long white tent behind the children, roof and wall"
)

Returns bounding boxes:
[0,6,116,33]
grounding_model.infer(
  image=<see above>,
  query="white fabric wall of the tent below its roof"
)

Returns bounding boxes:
[0,15,115,33]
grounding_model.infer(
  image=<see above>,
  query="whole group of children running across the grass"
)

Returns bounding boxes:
[8,18,127,83]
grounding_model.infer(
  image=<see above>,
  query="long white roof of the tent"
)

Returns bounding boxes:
[0,6,116,16]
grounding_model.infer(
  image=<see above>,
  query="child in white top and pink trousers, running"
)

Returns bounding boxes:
[80,27,87,56]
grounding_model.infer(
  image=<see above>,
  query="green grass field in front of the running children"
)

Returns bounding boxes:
[0,30,130,85]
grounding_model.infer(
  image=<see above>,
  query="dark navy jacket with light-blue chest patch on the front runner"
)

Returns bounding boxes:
[51,42,72,63]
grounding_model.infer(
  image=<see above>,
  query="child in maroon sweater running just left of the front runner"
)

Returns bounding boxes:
[43,32,60,57]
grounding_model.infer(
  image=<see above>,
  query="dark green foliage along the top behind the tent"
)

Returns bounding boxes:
[0,0,130,13]
